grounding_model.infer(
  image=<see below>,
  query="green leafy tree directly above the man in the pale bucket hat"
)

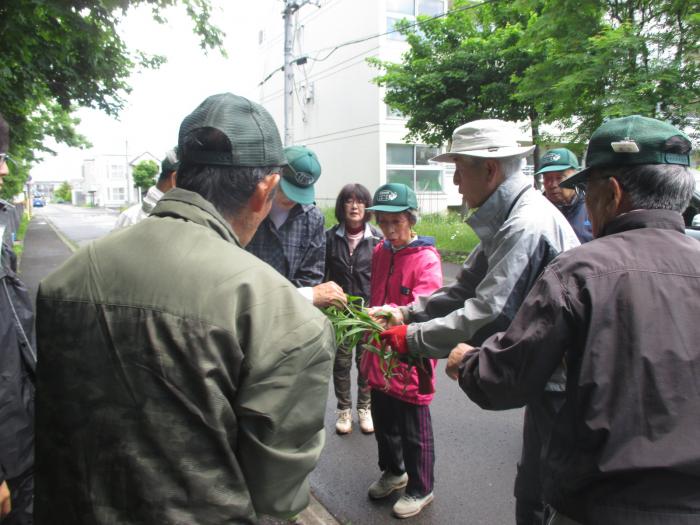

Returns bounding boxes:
[370,0,541,149]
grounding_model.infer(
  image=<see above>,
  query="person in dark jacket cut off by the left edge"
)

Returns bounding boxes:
[0,111,36,525]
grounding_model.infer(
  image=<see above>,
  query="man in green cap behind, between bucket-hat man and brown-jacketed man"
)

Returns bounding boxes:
[535,148,593,244]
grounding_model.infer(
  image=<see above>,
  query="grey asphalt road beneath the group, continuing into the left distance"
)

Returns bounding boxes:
[22,205,522,525]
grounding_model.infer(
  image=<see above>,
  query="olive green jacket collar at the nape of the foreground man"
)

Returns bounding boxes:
[151,188,241,246]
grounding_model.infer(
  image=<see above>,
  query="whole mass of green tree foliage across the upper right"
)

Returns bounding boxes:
[370,0,700,149]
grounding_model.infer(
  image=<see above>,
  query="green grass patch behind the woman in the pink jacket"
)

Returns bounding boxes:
[321,208,479,264]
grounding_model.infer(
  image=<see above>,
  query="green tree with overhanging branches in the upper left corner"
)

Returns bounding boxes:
[0,0,223,200]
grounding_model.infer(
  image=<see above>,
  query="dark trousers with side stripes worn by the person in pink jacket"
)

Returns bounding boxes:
[372,389,435,496]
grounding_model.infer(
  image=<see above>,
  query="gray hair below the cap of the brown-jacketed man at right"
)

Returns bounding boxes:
[596,164,695,213]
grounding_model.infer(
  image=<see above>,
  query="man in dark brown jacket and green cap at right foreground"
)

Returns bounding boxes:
[447,116,700,525]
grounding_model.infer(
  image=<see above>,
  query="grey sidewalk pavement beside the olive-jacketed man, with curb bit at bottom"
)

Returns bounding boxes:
[19,216,339,525]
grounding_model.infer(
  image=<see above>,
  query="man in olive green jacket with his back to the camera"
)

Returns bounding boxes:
[36,93,335,525]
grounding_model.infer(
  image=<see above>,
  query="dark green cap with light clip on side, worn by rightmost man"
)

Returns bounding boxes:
[560,115,691,188]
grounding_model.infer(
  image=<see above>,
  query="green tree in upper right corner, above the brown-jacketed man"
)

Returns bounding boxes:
[514,0,700,140]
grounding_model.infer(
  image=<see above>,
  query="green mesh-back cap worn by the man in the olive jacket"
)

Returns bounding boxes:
[178,93,287,168]
